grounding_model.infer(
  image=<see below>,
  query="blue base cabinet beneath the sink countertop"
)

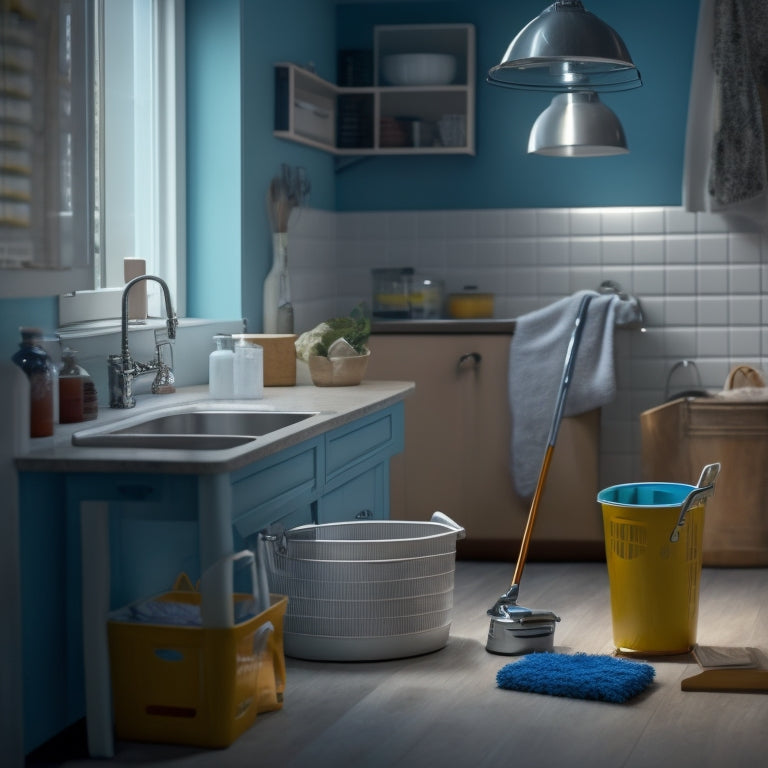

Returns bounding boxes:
[20,402,404,752]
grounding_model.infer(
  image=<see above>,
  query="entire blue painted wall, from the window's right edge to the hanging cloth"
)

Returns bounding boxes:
[0,0,699,340]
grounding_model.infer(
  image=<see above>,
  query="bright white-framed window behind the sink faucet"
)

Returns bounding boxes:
[59,0,186,325]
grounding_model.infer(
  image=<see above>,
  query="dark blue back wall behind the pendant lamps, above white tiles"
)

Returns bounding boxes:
[336,0,699,211]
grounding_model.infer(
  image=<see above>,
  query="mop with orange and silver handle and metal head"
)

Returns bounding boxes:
[486,295,592,655]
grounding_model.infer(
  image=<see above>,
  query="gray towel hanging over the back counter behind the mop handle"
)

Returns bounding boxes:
[509,291,620,498]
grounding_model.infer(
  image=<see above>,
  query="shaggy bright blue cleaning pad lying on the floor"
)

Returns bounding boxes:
[496,653,656,704]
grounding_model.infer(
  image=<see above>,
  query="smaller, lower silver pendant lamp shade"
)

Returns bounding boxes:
[528,91,629,157]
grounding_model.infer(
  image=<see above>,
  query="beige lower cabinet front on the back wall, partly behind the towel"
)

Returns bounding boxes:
[368,334,603,559]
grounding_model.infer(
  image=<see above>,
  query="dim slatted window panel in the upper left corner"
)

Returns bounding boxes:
[0,0,91,297]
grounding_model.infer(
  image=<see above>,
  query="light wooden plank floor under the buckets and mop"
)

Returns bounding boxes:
[27,561,768,768]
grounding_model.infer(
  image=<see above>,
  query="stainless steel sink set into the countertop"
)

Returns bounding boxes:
[72,410,317,450]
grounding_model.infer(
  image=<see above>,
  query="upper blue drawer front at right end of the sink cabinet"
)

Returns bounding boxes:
[325,404,402,482]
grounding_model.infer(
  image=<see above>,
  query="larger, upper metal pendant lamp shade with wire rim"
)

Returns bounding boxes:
[488,0,642,91]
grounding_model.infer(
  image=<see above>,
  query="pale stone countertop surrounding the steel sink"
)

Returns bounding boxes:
[15,381,414,475]
